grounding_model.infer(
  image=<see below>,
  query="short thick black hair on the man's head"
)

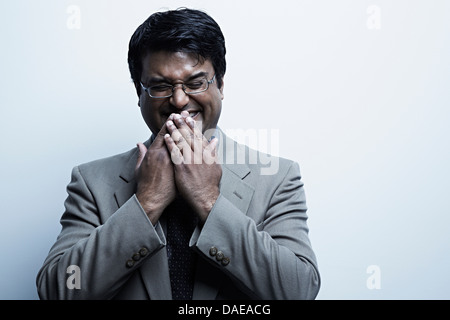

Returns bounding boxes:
[128,8,226,95]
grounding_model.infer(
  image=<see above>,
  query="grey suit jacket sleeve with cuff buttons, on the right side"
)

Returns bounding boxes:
[191,162,320,299]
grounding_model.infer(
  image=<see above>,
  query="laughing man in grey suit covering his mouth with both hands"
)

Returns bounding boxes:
[36,9,320,300]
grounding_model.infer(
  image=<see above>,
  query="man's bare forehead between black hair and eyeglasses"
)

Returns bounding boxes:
[141,51,214,81]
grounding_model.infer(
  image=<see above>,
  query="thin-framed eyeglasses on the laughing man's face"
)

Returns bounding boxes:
[141,75,216,99]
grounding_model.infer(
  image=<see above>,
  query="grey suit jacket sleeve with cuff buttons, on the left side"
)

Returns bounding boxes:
[36,167,165,299]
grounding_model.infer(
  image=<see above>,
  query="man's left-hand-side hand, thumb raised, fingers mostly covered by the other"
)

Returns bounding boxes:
[135,124,177,225]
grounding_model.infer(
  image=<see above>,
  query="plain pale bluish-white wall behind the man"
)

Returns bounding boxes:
[0,0,450,299]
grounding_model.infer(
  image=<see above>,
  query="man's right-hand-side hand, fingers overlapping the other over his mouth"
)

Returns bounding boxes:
[164,111,222,223]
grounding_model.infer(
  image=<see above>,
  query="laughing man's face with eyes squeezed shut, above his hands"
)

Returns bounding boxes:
[139,51,223,138]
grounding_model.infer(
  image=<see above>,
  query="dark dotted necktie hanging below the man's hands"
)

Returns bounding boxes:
[165,198,197,300]
